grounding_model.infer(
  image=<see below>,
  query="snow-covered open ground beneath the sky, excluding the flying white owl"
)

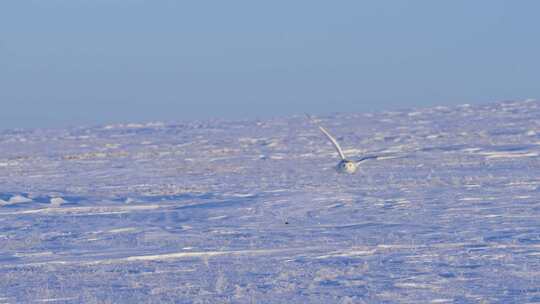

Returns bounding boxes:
[0,101,540,303]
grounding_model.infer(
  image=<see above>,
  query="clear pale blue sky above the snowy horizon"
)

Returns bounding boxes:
[0,0,540,129]
